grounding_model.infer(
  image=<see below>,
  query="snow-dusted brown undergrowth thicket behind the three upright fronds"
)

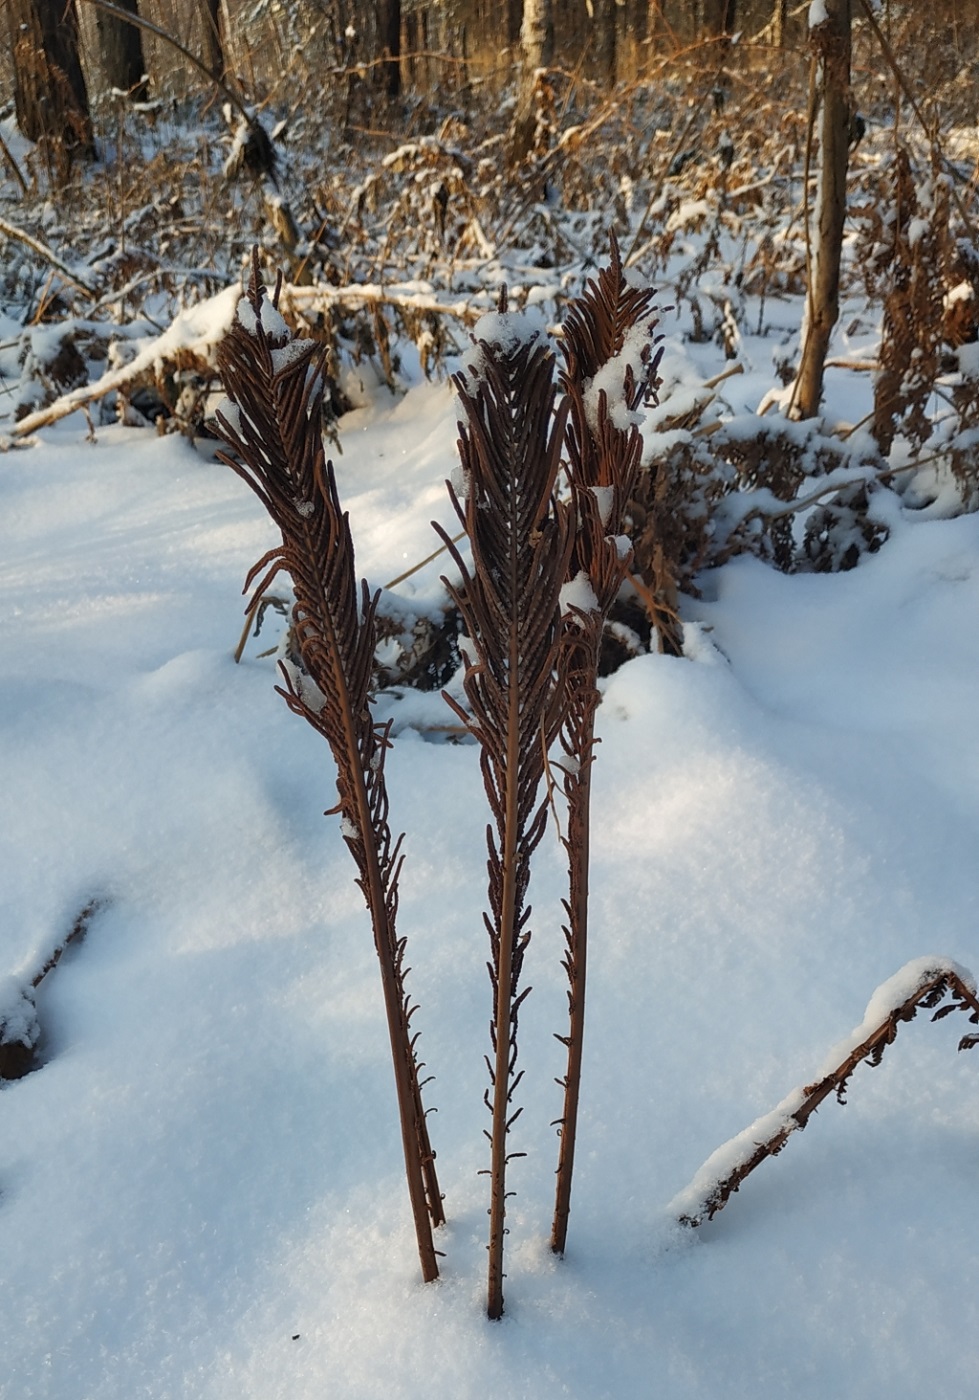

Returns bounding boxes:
[0,13,979,655]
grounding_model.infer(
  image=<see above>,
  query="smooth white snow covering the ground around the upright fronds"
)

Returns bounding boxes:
[0,330,979,1400]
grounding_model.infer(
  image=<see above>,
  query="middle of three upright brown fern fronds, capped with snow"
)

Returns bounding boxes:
[436,293,570,1319]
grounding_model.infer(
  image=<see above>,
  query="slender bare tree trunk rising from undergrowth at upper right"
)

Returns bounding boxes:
[794,0,852,419]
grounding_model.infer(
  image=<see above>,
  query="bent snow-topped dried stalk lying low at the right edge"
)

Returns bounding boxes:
[671,958,979,1225]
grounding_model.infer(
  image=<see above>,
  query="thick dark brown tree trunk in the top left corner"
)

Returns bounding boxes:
[8,0,94,160]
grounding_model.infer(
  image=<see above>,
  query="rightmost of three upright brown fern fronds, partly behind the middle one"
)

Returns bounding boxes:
[550,235,660,1254]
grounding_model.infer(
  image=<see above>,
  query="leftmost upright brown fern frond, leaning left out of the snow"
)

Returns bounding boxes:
[217,253,444,1281]
